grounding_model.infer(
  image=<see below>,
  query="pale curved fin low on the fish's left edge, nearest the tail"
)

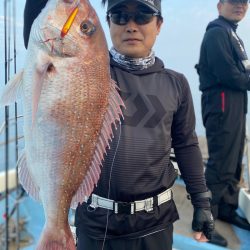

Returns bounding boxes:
[17,151,41,201]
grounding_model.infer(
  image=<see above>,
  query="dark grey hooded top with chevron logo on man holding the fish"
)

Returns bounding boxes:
[76,55,208,239]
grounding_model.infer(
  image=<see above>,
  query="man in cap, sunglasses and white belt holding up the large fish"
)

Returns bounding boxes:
[24,0,214,250]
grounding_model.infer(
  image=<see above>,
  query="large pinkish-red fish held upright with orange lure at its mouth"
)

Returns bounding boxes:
[1,0,123,250]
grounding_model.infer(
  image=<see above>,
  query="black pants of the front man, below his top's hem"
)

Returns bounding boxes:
[77,224,173,250]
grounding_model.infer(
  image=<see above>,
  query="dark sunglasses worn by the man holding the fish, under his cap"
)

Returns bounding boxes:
[108,11,160,25]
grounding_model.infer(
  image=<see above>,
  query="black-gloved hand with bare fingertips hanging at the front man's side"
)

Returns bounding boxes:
[192,208,214,242]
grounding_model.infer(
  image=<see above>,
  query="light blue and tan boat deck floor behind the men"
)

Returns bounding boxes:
[0,138,250,250]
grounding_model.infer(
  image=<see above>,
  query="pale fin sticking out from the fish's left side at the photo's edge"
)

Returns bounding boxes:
[0,71,24,106]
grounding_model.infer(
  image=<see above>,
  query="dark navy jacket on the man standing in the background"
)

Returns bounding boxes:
[198,16,250,91]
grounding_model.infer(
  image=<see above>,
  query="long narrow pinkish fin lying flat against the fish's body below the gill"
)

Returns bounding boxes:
[32,52,54,125]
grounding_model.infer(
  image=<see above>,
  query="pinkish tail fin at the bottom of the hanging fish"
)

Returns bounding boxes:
[36,226,76,250]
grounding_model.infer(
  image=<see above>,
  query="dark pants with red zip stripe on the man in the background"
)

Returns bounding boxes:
[202,89,247,218]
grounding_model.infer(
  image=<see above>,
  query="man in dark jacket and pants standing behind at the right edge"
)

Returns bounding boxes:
[197,0,250,244]
